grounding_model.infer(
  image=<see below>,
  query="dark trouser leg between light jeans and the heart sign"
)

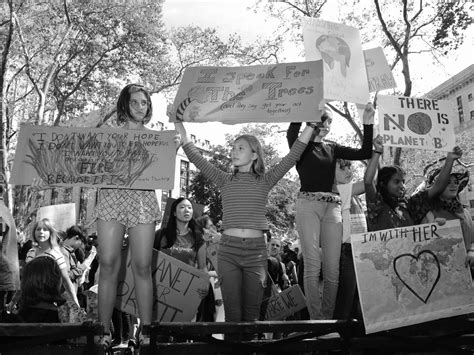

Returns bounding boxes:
[334,243,362,319]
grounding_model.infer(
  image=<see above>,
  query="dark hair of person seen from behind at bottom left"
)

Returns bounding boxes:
[20,256,65,308]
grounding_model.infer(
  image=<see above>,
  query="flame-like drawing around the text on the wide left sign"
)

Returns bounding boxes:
[25,133,153,187]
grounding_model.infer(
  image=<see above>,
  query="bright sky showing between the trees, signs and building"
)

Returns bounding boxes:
[154,0,474,144]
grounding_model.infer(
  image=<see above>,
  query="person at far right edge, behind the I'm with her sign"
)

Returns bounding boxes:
[421,169,474,277]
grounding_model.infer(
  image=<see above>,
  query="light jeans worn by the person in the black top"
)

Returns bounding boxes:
[296,198,342,319]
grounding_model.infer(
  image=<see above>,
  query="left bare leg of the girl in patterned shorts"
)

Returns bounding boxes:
[97,219,125,333]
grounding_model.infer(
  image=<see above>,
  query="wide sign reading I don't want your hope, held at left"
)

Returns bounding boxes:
[10,126,176,189]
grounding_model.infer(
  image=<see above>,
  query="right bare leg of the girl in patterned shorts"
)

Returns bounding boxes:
[129,223,155,325]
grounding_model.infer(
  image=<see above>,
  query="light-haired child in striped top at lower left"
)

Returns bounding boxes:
[26,218,79,305]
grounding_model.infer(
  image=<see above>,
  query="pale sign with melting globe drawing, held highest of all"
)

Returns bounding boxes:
[302,17,369,104]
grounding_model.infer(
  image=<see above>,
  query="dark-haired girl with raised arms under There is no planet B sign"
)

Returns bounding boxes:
[364,136,462,232]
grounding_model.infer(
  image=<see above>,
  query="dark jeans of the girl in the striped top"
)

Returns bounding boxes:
[217,234,267,322]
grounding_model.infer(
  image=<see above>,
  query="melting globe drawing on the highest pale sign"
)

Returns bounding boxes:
[316,35,351,77]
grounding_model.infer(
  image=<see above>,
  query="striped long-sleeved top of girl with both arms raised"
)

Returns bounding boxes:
[183,140,306,230]
